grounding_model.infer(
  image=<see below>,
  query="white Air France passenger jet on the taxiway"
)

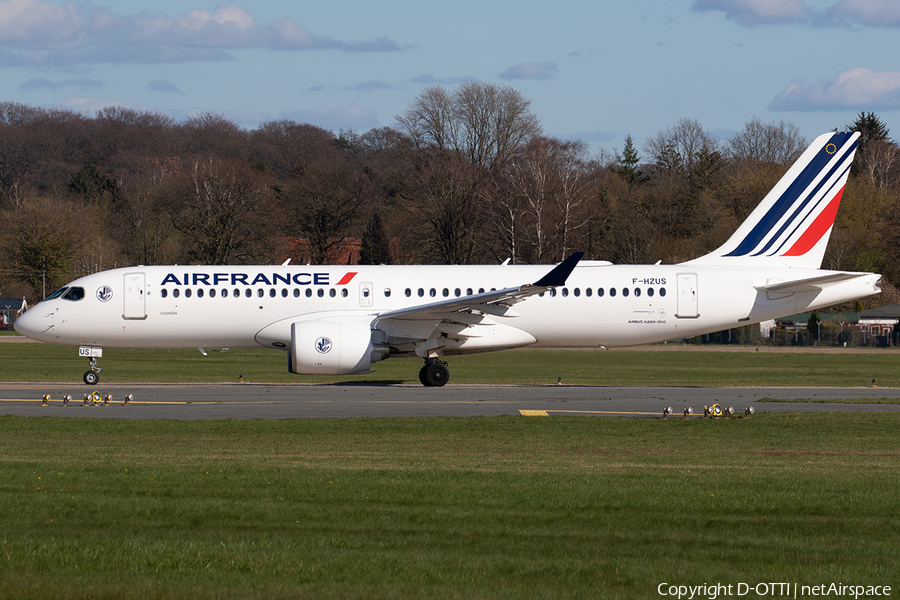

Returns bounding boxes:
[15,132,881,386]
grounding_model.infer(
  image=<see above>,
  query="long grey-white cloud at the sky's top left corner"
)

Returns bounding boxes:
[0,0,401,66]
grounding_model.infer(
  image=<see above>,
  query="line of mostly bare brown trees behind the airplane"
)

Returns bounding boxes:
[0,82,900,303]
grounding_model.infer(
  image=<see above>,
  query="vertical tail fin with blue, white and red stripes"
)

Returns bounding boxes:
[688,132,859,269]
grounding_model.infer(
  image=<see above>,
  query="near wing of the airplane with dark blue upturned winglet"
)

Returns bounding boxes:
[376,252,584,324]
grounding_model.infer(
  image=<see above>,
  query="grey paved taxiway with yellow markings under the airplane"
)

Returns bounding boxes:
[0,383,900,421]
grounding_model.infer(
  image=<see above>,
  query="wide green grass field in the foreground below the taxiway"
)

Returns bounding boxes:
[0,413,900,599]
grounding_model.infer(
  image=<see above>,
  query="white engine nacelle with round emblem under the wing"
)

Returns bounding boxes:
[288,320,390,375]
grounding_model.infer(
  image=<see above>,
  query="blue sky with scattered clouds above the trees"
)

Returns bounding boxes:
[0,0,900,156]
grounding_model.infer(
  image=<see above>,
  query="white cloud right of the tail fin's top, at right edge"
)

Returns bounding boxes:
[769,67,900,111]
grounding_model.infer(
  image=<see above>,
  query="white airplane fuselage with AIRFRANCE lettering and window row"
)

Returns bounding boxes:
[16,262,879,354]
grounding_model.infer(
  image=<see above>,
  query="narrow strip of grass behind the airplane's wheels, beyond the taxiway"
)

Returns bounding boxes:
[0,343,900,387]
